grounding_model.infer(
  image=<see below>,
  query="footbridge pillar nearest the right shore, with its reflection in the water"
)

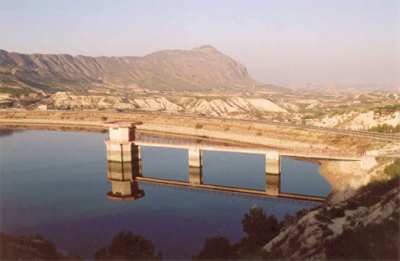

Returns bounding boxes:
[265,151,281,196]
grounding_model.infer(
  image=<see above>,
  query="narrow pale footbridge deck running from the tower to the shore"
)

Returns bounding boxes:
[133,136,364,161]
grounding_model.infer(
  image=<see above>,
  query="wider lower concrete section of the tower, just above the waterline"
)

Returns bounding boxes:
[106,140,142,162]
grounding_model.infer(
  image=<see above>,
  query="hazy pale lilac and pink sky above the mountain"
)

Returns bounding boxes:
[0,0,400,86]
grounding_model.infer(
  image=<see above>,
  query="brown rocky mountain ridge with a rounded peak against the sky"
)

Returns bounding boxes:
[0,45,254,92]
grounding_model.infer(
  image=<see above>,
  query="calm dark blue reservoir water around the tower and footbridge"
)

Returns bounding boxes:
[0,131,331,259]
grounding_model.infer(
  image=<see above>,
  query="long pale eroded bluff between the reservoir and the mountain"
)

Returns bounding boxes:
[42,92,287,116]
